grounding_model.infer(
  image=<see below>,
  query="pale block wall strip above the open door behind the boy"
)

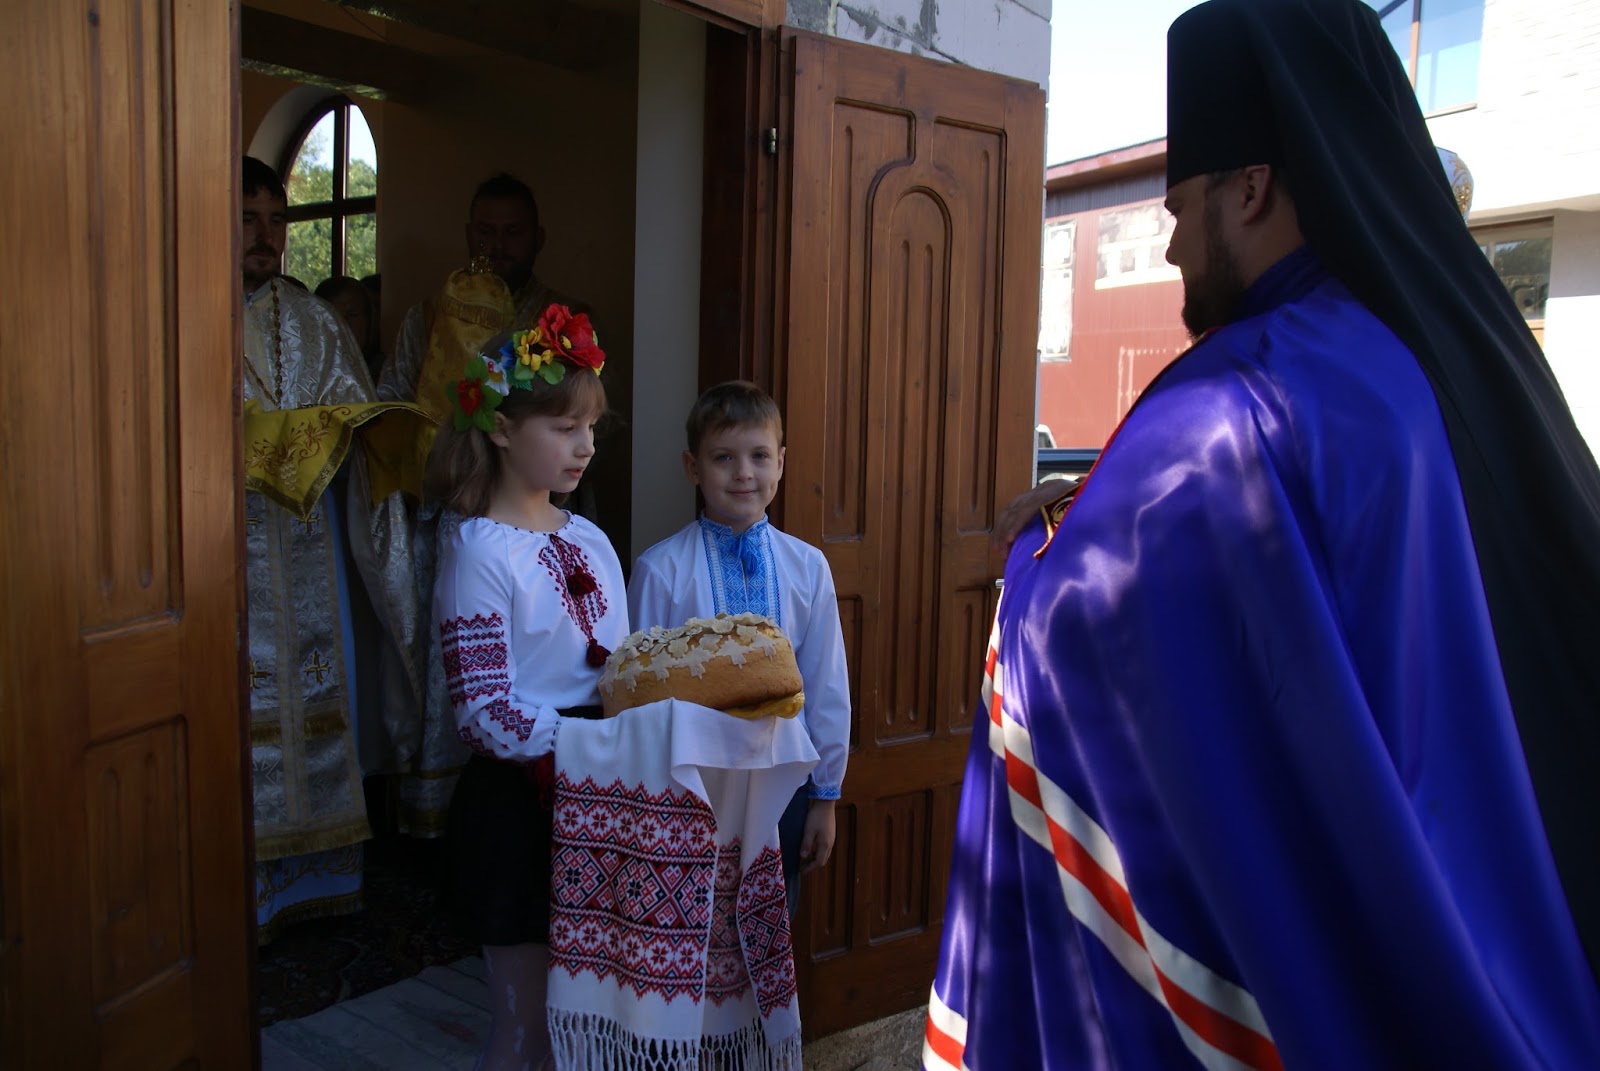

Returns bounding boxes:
[787,0,1051,88]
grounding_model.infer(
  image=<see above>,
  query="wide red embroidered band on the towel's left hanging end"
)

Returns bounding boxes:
[550,773,717,1004]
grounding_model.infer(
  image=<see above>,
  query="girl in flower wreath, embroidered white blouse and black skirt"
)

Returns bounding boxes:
[429,306,629,1071]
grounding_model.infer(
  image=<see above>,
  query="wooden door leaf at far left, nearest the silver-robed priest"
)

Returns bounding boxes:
[0,0,253,1068]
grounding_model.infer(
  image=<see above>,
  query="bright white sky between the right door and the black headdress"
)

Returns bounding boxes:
[1045,0,1198,163]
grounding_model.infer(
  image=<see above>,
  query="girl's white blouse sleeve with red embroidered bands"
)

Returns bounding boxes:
[434,525,560,762]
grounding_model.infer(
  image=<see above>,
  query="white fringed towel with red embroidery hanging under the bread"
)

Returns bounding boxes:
[549,700,816,1071]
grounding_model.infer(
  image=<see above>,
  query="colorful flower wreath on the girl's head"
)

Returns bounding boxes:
[450,304,605,432]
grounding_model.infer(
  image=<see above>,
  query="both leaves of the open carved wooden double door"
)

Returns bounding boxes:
[0,0,1043,1068]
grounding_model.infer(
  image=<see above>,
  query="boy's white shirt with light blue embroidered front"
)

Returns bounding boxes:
[627,519,850,799]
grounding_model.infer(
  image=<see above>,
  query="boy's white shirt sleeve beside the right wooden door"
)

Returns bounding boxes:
[790,552,850,799]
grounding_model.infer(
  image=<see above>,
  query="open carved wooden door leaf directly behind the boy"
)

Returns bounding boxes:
[778,32,1045,1036]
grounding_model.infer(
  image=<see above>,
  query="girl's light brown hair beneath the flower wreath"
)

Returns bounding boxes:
[422,336,606,517]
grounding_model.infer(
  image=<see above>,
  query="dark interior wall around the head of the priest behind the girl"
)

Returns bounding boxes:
[240,0,638,557]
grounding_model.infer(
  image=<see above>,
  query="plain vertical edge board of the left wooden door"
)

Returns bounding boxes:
[170,0,256,1068]
